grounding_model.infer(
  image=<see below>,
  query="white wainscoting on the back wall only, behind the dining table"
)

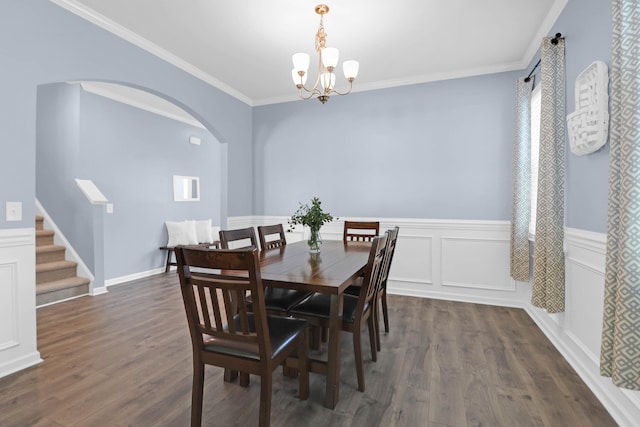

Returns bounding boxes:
[228,216,527,307]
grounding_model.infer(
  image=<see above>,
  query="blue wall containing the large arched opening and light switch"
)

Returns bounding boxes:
[0,0,253,236]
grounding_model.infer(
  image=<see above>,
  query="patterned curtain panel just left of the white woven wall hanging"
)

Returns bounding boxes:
[532,37,566,313]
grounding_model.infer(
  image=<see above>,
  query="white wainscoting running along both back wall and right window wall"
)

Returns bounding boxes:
[228,217,640,427]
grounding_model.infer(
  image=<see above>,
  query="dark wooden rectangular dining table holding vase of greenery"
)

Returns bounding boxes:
[260,240,371,409]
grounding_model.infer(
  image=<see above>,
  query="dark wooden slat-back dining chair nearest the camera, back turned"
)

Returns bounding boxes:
[175,247,309,427]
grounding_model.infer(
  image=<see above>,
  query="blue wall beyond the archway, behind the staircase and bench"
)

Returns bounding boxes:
[36,83,226,279]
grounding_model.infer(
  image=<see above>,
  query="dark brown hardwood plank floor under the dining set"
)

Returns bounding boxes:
[0,273,616,427]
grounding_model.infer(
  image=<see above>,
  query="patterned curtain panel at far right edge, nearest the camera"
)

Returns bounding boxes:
[600,0,640,390]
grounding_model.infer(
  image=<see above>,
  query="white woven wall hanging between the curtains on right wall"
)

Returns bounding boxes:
[567,61,609,156]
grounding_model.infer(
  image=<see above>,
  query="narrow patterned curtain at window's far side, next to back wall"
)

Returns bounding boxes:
[511,77,533,282]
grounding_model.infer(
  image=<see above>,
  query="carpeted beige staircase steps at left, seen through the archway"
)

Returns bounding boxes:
[36,216,90,306]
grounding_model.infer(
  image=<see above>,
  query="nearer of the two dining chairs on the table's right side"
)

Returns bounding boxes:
[289,236,387,391]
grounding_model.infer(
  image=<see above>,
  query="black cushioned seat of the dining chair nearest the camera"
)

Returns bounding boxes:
[204,313,307,360]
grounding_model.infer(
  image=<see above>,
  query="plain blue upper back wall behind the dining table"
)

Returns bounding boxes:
[253,73,517,220]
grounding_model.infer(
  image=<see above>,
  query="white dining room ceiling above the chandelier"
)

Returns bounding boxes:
[51,0,568,106]
